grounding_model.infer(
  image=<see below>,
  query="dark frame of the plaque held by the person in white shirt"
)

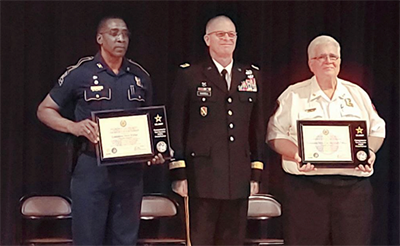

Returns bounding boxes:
[297,120,370,168]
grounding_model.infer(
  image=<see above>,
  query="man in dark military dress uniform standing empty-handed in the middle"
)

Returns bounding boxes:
[169,16,265,246]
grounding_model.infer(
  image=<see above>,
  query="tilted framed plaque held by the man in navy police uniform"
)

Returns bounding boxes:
[92,106,171,166]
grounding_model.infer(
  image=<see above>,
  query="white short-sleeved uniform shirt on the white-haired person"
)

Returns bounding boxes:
[267,76,385,177]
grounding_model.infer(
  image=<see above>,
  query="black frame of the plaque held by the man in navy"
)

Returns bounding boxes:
[92,106,171,166]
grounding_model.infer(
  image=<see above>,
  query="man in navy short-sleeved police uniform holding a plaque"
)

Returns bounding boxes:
[37,17,164,246]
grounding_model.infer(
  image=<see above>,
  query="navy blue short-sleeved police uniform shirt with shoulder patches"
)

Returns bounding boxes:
[50,53,152,121]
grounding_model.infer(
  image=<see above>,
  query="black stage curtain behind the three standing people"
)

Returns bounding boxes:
[0,0,400,246]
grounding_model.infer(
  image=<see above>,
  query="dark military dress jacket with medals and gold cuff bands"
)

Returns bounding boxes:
[169,59,266,199]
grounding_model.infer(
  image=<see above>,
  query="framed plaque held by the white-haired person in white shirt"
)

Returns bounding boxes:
[297,120,369,168]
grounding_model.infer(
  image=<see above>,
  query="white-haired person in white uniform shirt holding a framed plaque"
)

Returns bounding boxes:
[267,36,385,246]
